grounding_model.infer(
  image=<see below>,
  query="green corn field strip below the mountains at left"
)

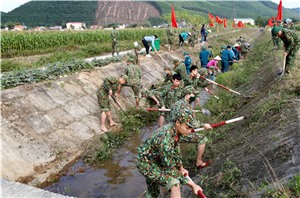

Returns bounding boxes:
[1,28,171,53]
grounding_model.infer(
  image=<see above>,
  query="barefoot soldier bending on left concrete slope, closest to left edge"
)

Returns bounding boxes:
[97,76,128,132]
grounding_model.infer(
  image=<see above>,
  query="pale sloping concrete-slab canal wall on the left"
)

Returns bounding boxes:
[0,52,188,186]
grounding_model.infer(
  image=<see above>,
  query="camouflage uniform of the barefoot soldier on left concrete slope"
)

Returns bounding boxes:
[97,77,119,112]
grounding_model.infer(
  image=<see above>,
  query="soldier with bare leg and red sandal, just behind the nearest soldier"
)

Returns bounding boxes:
[170,85,212,168]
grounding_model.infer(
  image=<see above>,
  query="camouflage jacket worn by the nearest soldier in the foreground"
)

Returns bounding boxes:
[137,123,188,185]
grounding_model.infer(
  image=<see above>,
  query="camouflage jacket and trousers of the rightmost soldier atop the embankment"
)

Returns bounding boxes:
[280,28,300,71]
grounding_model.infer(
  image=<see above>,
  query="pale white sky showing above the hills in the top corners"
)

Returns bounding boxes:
[0,0,300,12]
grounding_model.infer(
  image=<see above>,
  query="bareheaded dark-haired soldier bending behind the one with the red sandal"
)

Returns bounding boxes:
[158,74,183,127]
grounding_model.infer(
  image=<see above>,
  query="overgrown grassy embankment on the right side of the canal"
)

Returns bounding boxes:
[183,29,300,197]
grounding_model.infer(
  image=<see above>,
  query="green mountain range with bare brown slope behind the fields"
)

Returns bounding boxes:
[1,0,299,27]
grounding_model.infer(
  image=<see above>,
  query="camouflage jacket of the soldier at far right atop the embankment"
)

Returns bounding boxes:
[280,28,299,54]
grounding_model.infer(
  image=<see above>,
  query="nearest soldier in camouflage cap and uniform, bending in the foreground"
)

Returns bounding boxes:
[136,106,202,197]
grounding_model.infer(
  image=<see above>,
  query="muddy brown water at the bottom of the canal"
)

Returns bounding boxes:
[45,123,158,198]
